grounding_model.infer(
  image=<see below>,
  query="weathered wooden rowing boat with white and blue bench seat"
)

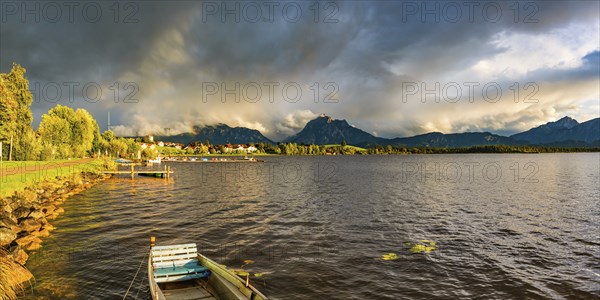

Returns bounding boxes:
[148,238,267,300]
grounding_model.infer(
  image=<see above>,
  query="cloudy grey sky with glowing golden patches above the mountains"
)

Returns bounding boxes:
[0,1,600,140]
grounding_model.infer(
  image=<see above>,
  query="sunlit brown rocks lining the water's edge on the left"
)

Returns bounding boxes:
[0,172,109,298]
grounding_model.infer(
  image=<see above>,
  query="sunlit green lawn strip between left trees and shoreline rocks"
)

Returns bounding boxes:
[0,159,102,197]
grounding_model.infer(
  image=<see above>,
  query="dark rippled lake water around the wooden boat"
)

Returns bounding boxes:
[21,153,600,299]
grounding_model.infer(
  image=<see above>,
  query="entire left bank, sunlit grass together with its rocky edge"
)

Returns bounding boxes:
[0,159,112,300]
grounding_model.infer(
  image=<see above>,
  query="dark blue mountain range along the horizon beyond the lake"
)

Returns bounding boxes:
[155,115,600,148]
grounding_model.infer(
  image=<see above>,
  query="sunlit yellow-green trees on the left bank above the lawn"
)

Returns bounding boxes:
[0,64,156,160]
